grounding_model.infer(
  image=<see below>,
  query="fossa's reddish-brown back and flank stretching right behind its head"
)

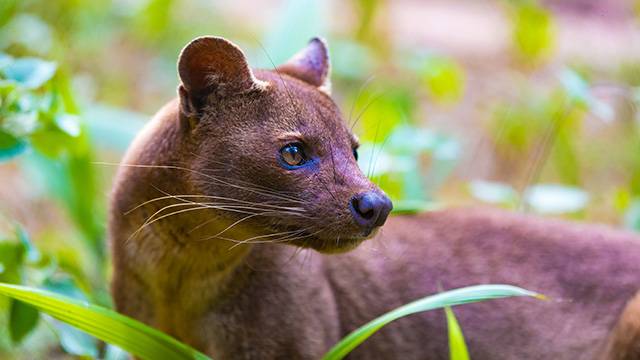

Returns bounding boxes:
[328,209,640,359]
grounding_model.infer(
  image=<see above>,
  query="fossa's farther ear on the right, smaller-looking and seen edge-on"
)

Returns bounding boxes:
[277,38,331,94]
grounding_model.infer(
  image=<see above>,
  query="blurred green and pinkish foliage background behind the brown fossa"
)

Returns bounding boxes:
[0,0,640,359]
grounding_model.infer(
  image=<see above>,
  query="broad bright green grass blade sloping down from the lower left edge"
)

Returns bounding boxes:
[0,283,209,360]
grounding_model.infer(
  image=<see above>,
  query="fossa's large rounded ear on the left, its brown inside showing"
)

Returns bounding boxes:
[178,36,266,117]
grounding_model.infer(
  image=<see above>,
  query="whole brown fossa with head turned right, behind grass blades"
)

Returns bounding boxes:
[109,38,640,359]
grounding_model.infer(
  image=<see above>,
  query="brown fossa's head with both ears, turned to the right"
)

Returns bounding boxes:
[178,37,392,252]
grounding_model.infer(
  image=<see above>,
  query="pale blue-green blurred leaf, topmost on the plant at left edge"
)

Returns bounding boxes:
[2,58,56,89]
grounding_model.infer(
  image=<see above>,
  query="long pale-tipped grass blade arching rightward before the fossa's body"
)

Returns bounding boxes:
[323,285,544,360]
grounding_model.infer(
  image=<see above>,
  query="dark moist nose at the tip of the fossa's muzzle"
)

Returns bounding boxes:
[350,191,393,230]
